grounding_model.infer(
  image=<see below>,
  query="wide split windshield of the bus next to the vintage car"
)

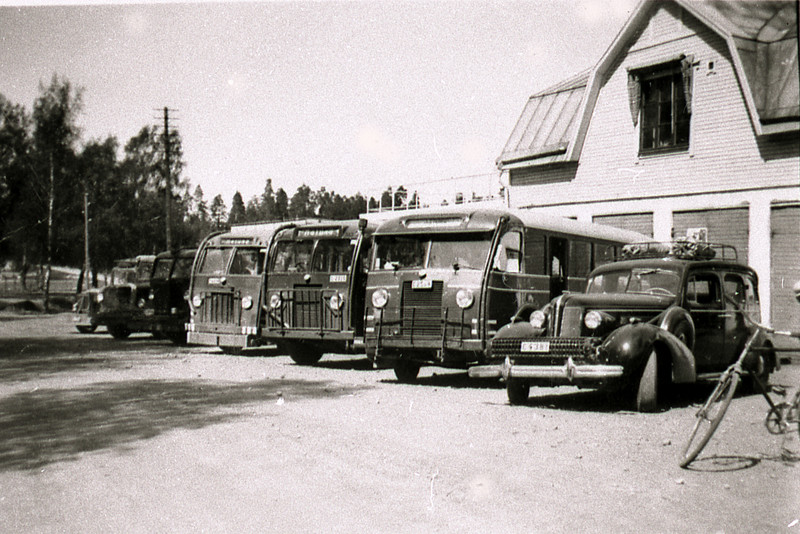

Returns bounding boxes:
[374,234,491,270]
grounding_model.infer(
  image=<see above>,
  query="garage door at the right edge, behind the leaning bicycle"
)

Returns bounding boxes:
[770,205,800,330]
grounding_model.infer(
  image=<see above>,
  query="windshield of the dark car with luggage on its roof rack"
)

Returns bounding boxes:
[586,267,680,297]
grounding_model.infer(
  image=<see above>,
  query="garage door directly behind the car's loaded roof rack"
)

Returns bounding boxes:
[672,208,750,263]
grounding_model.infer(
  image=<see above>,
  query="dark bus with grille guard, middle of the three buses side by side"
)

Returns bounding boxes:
[262,219,376,365]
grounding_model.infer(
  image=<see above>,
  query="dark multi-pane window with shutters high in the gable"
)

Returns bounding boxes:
[628,58,692,155]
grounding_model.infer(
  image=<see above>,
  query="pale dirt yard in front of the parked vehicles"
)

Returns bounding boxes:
[0,314,800,533]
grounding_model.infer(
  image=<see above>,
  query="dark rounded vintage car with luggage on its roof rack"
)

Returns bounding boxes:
[470,242,778,411]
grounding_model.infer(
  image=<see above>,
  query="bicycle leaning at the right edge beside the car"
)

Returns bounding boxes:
[680,324,800,468]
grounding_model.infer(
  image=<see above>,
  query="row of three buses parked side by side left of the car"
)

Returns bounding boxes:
[186,208,649,381]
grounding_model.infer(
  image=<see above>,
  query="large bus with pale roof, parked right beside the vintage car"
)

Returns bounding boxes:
[364,208,650,382]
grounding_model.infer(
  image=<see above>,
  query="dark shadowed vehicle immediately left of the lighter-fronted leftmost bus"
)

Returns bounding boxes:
[145,248,196,345]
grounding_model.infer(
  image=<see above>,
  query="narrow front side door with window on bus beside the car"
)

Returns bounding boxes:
[486,229,525,338]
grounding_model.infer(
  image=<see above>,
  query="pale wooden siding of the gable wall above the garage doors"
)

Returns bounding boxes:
[511,3,800,211]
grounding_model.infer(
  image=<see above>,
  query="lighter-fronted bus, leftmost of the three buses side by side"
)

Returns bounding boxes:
[186,220,326,354]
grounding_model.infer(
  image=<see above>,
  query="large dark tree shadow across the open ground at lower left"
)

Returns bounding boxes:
[0,380,364,471]
